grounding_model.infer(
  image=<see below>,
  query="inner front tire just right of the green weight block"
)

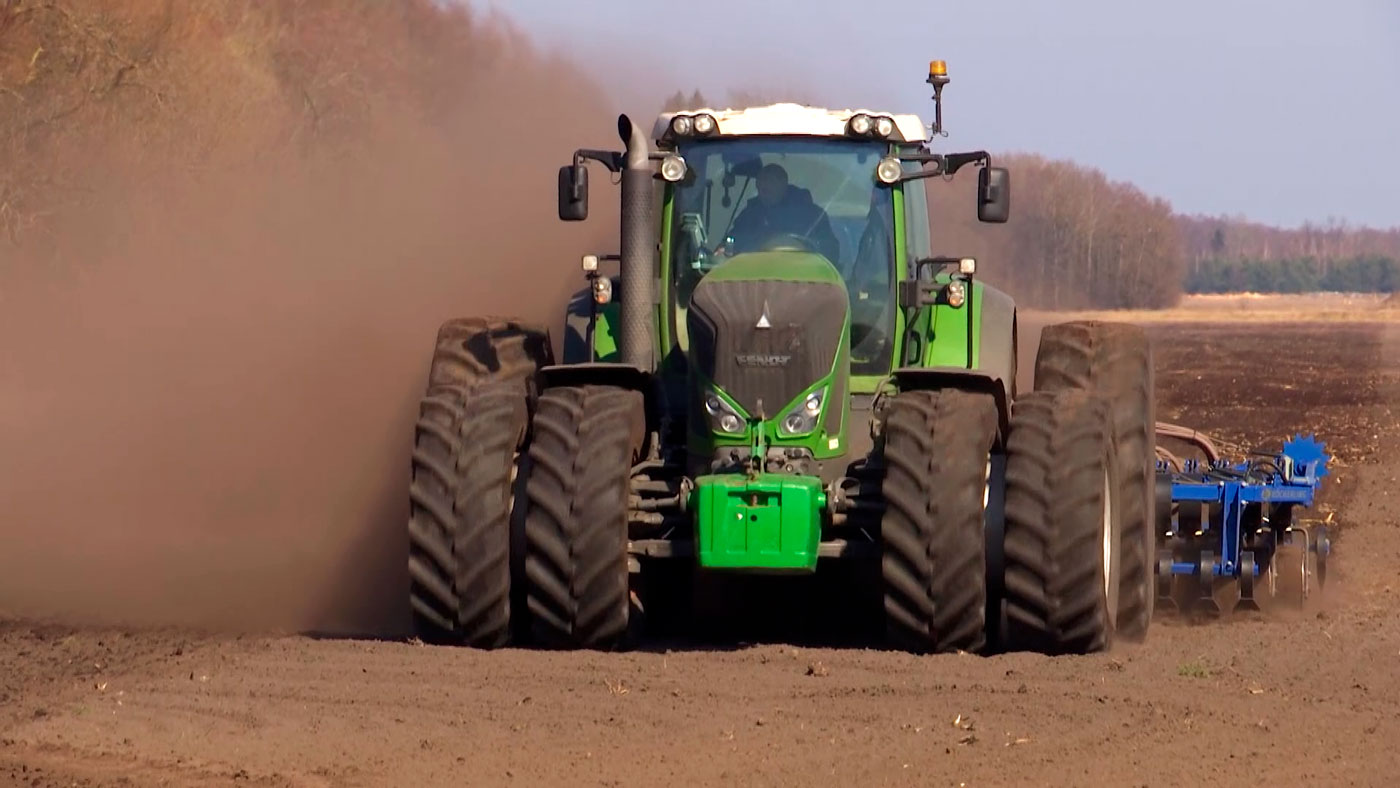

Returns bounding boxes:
[881,391,997,652]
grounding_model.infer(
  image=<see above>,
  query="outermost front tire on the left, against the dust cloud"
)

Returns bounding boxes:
[409,382,528,648]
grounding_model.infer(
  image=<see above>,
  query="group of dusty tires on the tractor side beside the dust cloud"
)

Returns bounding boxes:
[407,319,644,648]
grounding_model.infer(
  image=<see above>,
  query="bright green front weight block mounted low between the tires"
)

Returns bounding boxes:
[690,474,826,574]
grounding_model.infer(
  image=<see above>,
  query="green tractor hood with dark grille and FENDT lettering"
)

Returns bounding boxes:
[686,252,850,420]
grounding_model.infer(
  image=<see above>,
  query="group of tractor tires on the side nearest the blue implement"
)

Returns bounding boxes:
[881,323,1155,654]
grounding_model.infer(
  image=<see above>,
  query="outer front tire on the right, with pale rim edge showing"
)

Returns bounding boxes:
[1004,389,1121,654]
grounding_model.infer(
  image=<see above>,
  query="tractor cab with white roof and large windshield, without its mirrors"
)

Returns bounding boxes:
[654,111,930,375]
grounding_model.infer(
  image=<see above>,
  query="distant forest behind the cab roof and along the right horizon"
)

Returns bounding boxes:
[665,91,1400,309]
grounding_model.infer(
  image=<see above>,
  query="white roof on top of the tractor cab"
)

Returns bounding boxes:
[652,104,928,143]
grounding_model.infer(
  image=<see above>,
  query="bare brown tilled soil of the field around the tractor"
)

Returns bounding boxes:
[0,321,1400,787]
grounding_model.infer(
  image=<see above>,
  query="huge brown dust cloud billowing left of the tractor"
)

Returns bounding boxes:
[0,0,632,634]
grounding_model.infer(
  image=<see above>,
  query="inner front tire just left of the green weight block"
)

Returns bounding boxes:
[525,386,645,649]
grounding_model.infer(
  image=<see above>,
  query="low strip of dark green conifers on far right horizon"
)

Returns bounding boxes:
[1186,256,1400,293]
